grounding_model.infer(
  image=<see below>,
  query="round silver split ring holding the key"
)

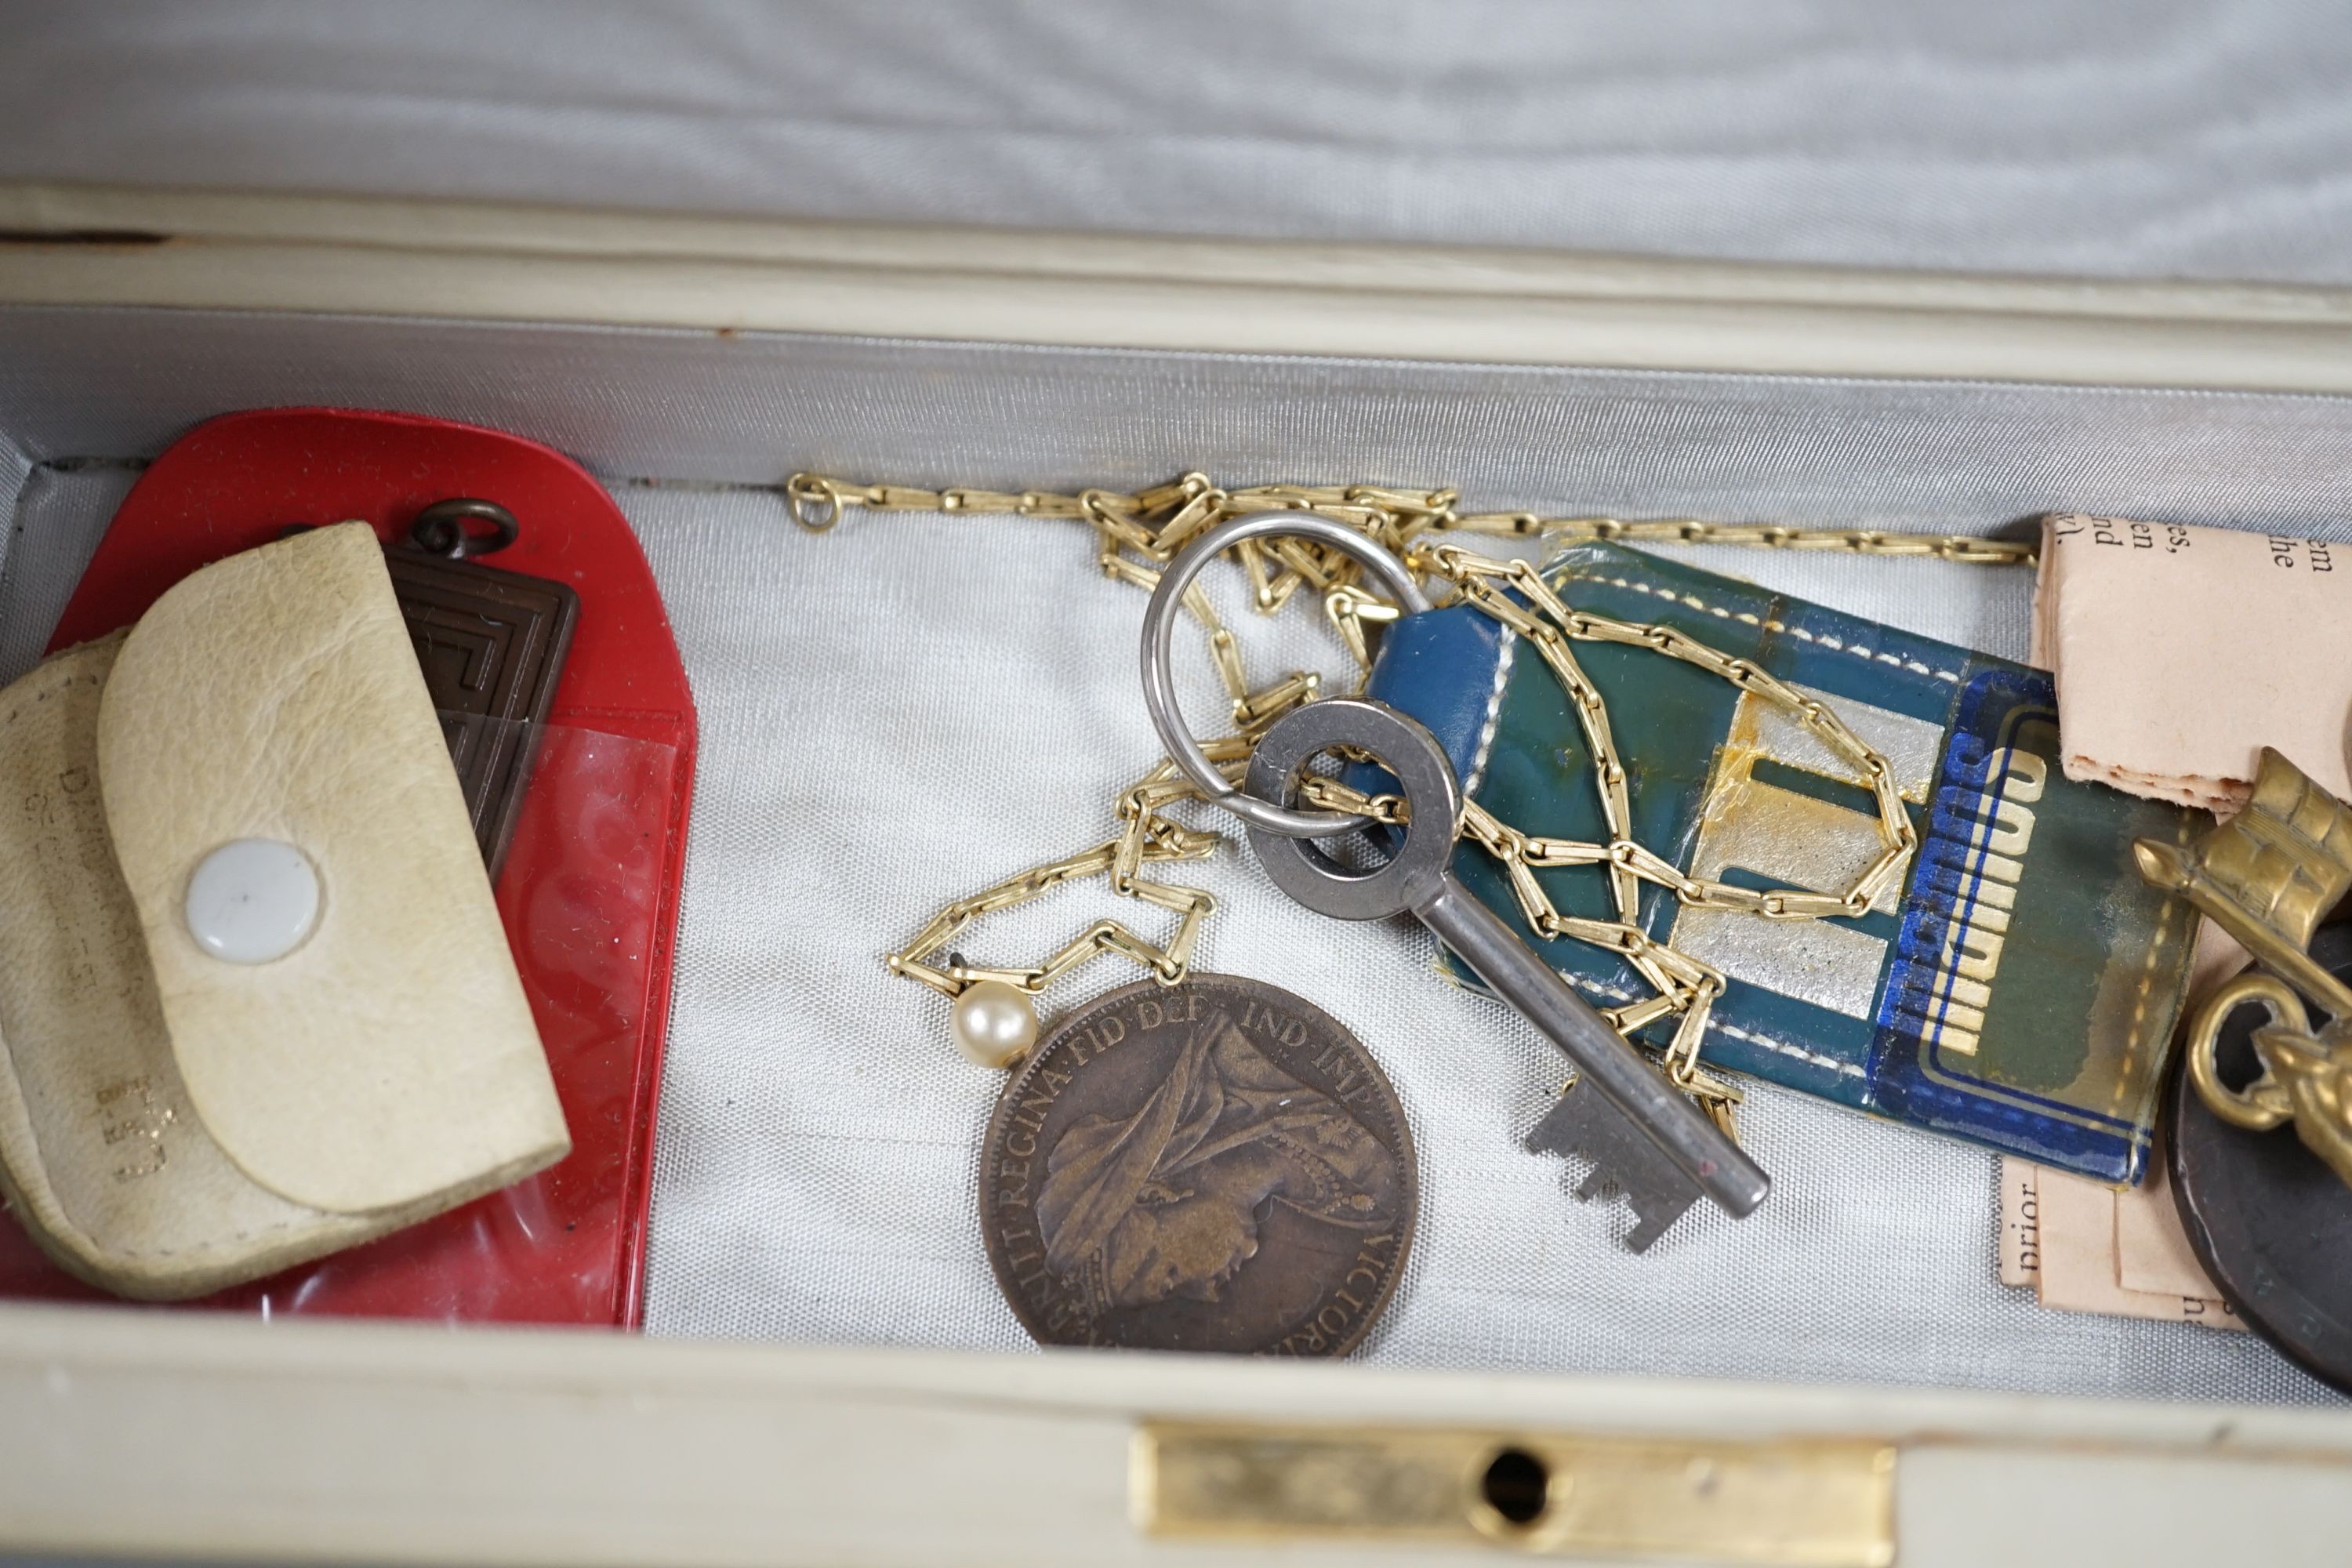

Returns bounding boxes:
[1143,513,1430,839]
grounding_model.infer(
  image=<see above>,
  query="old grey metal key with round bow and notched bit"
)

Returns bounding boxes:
[1247,699,1771,1253]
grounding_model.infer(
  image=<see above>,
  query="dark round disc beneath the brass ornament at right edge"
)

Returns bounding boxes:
[2171,921,2352,1394]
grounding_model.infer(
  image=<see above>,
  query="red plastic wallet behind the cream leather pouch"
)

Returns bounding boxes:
[0,409,696,1328]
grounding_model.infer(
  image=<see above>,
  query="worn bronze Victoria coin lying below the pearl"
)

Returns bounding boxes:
[981,973,1421,1356]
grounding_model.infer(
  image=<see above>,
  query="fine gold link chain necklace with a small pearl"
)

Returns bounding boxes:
[818,473,2034,1133]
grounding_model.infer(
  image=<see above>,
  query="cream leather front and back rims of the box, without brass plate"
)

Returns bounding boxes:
[0,188,2352,1568]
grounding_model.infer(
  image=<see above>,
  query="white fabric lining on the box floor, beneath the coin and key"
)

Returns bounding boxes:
[623,492,2324,1401]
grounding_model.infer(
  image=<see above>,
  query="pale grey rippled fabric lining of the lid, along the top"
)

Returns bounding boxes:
[0,0,2352,285]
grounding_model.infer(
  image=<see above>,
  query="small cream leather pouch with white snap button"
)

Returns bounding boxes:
[0,524,572,1300]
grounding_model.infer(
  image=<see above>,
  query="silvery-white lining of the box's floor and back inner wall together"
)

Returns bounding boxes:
[0,310,2352,1401]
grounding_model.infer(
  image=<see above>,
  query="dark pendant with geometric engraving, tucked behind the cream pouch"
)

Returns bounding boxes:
[383,548,579,879]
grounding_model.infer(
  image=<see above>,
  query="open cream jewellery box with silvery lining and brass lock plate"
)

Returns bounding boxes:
[0,186,2352,1566]
